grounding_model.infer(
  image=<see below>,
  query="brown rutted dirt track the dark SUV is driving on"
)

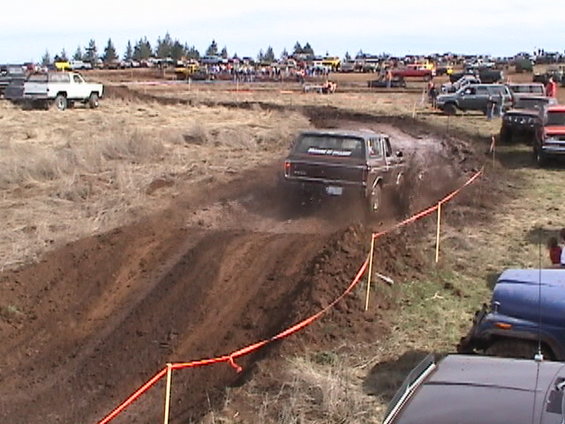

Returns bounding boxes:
[0,105,476,423]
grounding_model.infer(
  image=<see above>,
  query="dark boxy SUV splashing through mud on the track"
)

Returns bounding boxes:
[284,130,404,215]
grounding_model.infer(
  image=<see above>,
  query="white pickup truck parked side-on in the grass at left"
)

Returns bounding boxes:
[22,72,104,110]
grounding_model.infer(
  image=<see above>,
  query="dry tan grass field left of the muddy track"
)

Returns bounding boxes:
[0,100,309,269]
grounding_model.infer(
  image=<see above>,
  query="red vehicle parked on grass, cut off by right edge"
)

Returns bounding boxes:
[534,105,565,166]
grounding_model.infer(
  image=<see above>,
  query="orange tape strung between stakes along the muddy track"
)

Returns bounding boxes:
[94,166,483,424]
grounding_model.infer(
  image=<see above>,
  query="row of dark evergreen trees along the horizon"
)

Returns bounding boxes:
[41,33,320,66]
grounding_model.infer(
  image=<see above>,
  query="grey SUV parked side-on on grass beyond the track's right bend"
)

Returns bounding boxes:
[436,84,512,115]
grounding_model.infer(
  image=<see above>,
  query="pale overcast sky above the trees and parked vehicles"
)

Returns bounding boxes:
[0,0,565,63]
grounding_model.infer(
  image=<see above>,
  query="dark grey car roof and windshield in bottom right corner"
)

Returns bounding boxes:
[383,355,565,424]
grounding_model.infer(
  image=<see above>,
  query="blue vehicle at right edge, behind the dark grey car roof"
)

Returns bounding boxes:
[457,269,565,361]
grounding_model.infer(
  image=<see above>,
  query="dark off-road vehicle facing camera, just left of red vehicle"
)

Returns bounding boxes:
[500,95,557,143]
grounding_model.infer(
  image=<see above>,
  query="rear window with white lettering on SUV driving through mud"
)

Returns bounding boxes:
[295,134,365,158]
